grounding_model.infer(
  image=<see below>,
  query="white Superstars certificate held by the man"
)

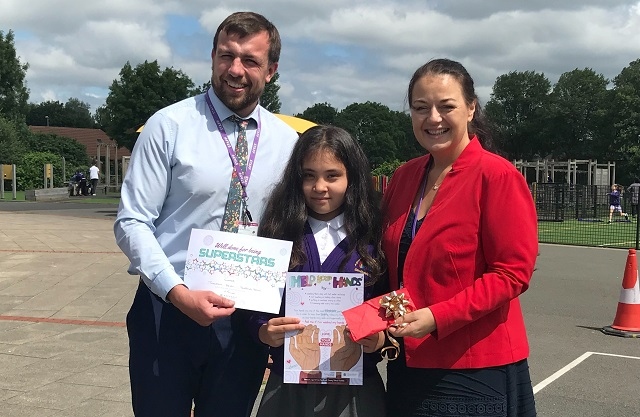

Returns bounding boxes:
[184,229,293,314]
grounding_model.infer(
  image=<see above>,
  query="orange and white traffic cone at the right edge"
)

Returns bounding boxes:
[602,249,640,337]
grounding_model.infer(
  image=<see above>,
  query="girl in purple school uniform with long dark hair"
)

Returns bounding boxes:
[253,126,387,417]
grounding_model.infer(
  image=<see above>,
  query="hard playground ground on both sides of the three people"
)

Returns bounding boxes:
[0,200,640,417]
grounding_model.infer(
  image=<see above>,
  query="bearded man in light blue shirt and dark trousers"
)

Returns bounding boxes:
[114,12,298,417]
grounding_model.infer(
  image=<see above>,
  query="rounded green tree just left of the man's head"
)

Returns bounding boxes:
[96,61,195,149]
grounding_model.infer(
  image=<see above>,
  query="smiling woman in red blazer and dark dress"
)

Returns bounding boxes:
[383,59,538,417]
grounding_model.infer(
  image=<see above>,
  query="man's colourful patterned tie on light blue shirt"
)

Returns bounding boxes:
[220,115,249,233]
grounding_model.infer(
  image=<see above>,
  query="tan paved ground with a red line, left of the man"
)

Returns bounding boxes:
[0,202,132,417]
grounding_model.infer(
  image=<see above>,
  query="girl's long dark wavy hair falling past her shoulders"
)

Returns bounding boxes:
[258,126,384,285]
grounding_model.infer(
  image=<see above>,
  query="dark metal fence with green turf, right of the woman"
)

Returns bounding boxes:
[530,183,640,249]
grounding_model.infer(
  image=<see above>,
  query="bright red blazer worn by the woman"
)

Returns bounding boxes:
[383,137,538,368]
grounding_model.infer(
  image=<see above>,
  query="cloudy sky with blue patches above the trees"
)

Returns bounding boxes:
[0,0,640,118]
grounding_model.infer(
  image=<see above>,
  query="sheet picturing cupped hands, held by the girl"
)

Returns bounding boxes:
[283,272,364,385]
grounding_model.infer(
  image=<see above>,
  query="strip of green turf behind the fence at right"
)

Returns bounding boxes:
[538,215,636,249]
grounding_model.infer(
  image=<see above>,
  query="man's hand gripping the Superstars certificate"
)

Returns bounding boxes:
[167,285,236,326]
